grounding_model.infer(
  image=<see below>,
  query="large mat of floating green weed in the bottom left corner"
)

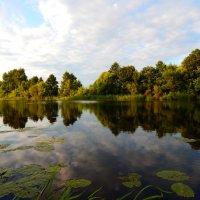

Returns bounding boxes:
[0,164,63,199]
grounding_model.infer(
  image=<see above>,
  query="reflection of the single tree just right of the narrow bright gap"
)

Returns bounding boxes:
[60,101,82,126]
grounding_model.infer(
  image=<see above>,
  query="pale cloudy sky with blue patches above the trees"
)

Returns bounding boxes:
[0,0,200,86]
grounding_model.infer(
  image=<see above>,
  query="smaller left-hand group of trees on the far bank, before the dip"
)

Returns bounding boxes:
[0,69,82,99]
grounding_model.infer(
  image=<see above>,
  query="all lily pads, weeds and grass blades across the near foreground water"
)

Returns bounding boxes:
[0,164,195,200]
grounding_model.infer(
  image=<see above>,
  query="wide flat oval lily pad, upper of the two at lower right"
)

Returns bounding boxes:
[156,170,190,181]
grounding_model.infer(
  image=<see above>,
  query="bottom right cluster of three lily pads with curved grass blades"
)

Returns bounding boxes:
[119,170,195,200]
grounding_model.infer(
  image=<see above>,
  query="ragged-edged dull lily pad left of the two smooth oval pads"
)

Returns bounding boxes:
[119,173,142,188]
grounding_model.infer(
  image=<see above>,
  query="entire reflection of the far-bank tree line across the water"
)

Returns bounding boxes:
[0,101,200,149]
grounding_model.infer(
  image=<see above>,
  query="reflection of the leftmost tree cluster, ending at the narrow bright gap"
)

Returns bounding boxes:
[0,101,58,129]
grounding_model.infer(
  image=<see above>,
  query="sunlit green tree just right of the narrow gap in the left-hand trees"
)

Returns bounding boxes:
[60,72,82,96]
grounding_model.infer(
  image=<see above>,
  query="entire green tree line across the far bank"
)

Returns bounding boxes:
[0,49,200,99]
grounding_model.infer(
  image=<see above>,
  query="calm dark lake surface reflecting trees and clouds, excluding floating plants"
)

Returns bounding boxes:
[0,101,200,200]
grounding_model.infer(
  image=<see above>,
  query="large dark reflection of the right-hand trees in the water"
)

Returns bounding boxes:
[81,102,200,149]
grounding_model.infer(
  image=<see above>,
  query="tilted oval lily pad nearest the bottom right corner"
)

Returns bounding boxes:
[171,183,194,197]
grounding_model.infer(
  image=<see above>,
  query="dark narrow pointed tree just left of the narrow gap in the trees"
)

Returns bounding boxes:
[45,74,58,97]
